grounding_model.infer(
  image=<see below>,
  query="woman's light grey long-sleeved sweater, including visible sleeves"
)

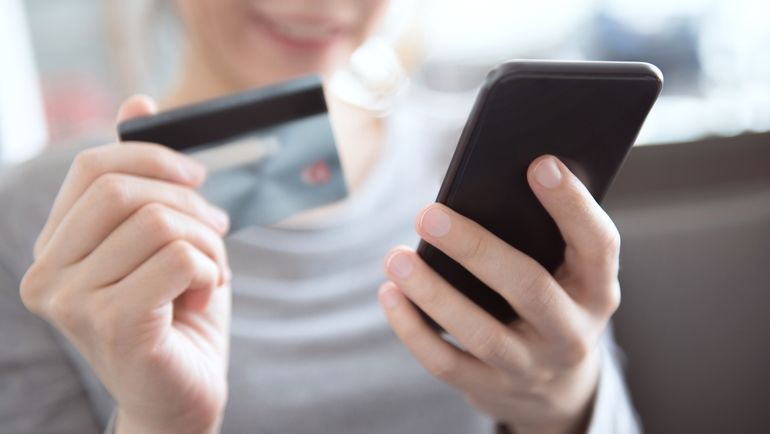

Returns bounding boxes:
[0,96,638,434]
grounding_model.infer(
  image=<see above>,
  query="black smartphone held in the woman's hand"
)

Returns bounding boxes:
[417,60,663,328]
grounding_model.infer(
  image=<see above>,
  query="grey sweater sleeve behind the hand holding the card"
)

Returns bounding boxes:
[0,147,112,434]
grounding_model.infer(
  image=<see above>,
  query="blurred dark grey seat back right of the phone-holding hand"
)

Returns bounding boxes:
[605,134,770,434]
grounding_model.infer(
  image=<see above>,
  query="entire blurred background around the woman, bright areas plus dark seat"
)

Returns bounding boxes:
[0,0,770,433]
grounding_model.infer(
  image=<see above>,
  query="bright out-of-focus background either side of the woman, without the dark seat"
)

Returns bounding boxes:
[0,0,770,162]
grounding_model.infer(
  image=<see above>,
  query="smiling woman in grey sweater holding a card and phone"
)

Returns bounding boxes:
[0,0,636,433]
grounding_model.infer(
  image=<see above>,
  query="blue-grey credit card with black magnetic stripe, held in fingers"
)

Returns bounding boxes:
[118,76,347,233]
